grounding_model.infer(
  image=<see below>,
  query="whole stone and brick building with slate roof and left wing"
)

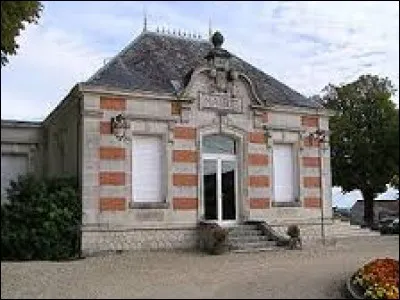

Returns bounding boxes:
[1,27,332,253]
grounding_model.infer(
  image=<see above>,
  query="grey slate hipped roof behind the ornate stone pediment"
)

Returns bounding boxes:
[82,32,321,108]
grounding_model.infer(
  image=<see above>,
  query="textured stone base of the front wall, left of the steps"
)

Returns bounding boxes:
[82,228,198,255]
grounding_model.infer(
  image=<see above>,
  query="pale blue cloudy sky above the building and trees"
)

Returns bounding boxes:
[1,1,399,203]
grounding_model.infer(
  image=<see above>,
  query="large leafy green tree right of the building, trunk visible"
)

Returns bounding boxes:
[322,75,399,226]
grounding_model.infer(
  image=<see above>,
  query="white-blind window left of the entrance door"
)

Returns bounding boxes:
[132,135,164,203]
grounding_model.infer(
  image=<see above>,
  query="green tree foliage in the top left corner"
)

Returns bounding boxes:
[1,1,43,66]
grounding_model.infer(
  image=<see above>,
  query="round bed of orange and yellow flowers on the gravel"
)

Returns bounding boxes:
[352,258,399,299]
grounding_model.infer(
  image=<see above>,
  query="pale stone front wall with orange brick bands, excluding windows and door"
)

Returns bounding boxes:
[77,67,331,252]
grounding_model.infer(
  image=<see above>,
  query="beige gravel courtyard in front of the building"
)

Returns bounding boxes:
[1,236,399,299]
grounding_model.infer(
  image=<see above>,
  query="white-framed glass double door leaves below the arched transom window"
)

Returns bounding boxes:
[202,154,237,223]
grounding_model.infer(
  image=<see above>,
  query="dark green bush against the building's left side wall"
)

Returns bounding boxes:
[1,175,82,260]
